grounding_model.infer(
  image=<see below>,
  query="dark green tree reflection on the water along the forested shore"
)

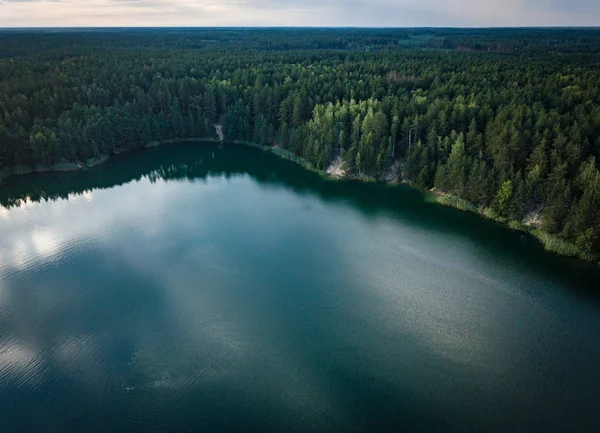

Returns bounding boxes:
[0,143,600,297]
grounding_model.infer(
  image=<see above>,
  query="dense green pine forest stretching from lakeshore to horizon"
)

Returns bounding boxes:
[0,28,600,257]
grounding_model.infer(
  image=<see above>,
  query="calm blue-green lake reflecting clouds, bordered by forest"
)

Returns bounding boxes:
[0,144,600,433]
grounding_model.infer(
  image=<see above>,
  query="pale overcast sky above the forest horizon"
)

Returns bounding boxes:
[0,0,600,27]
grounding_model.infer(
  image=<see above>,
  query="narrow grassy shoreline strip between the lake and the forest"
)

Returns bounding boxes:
[0,134,600,266]
